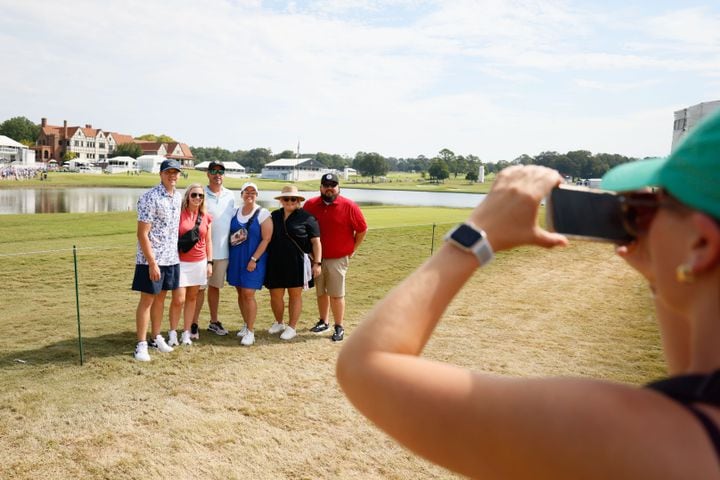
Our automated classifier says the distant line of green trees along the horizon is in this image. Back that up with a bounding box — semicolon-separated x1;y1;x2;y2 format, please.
0;117;636;182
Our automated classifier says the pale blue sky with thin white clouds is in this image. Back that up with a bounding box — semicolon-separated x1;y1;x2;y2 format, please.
0;0;720;161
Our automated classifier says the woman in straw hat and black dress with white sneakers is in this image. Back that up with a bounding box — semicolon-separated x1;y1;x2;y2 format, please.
265;185;322;340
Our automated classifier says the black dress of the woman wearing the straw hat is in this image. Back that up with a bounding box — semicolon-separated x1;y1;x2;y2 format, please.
265;208;320;288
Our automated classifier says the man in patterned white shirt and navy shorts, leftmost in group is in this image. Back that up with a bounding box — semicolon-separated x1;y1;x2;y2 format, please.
132;160;182;362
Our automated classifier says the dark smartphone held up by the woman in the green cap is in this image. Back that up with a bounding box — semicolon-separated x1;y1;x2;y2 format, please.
545;185;633;244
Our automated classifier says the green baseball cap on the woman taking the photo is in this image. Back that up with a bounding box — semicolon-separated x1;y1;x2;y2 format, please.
600;110;720;219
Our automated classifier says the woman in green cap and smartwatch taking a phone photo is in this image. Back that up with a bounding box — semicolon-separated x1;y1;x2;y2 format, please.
337;113;720;480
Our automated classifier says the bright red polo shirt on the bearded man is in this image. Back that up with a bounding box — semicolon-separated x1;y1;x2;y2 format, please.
303;195;367;258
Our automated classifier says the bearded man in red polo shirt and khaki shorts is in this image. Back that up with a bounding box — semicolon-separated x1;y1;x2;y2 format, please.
303;173;367;342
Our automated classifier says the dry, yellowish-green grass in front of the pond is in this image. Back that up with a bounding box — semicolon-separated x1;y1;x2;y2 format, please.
0;207;664;479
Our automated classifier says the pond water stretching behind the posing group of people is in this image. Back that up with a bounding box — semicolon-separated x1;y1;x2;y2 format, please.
0;188;485;214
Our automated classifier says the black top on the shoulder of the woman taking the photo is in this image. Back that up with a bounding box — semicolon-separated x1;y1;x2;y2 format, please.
646;370;720;459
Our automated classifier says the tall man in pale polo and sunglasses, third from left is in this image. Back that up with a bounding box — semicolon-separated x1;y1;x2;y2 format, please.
190;161;235;339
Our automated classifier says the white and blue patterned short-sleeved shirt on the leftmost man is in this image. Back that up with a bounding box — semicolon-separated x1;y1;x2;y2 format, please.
135;183;182;266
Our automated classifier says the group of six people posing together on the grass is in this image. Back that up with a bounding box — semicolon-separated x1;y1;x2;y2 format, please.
132;160;367;361
